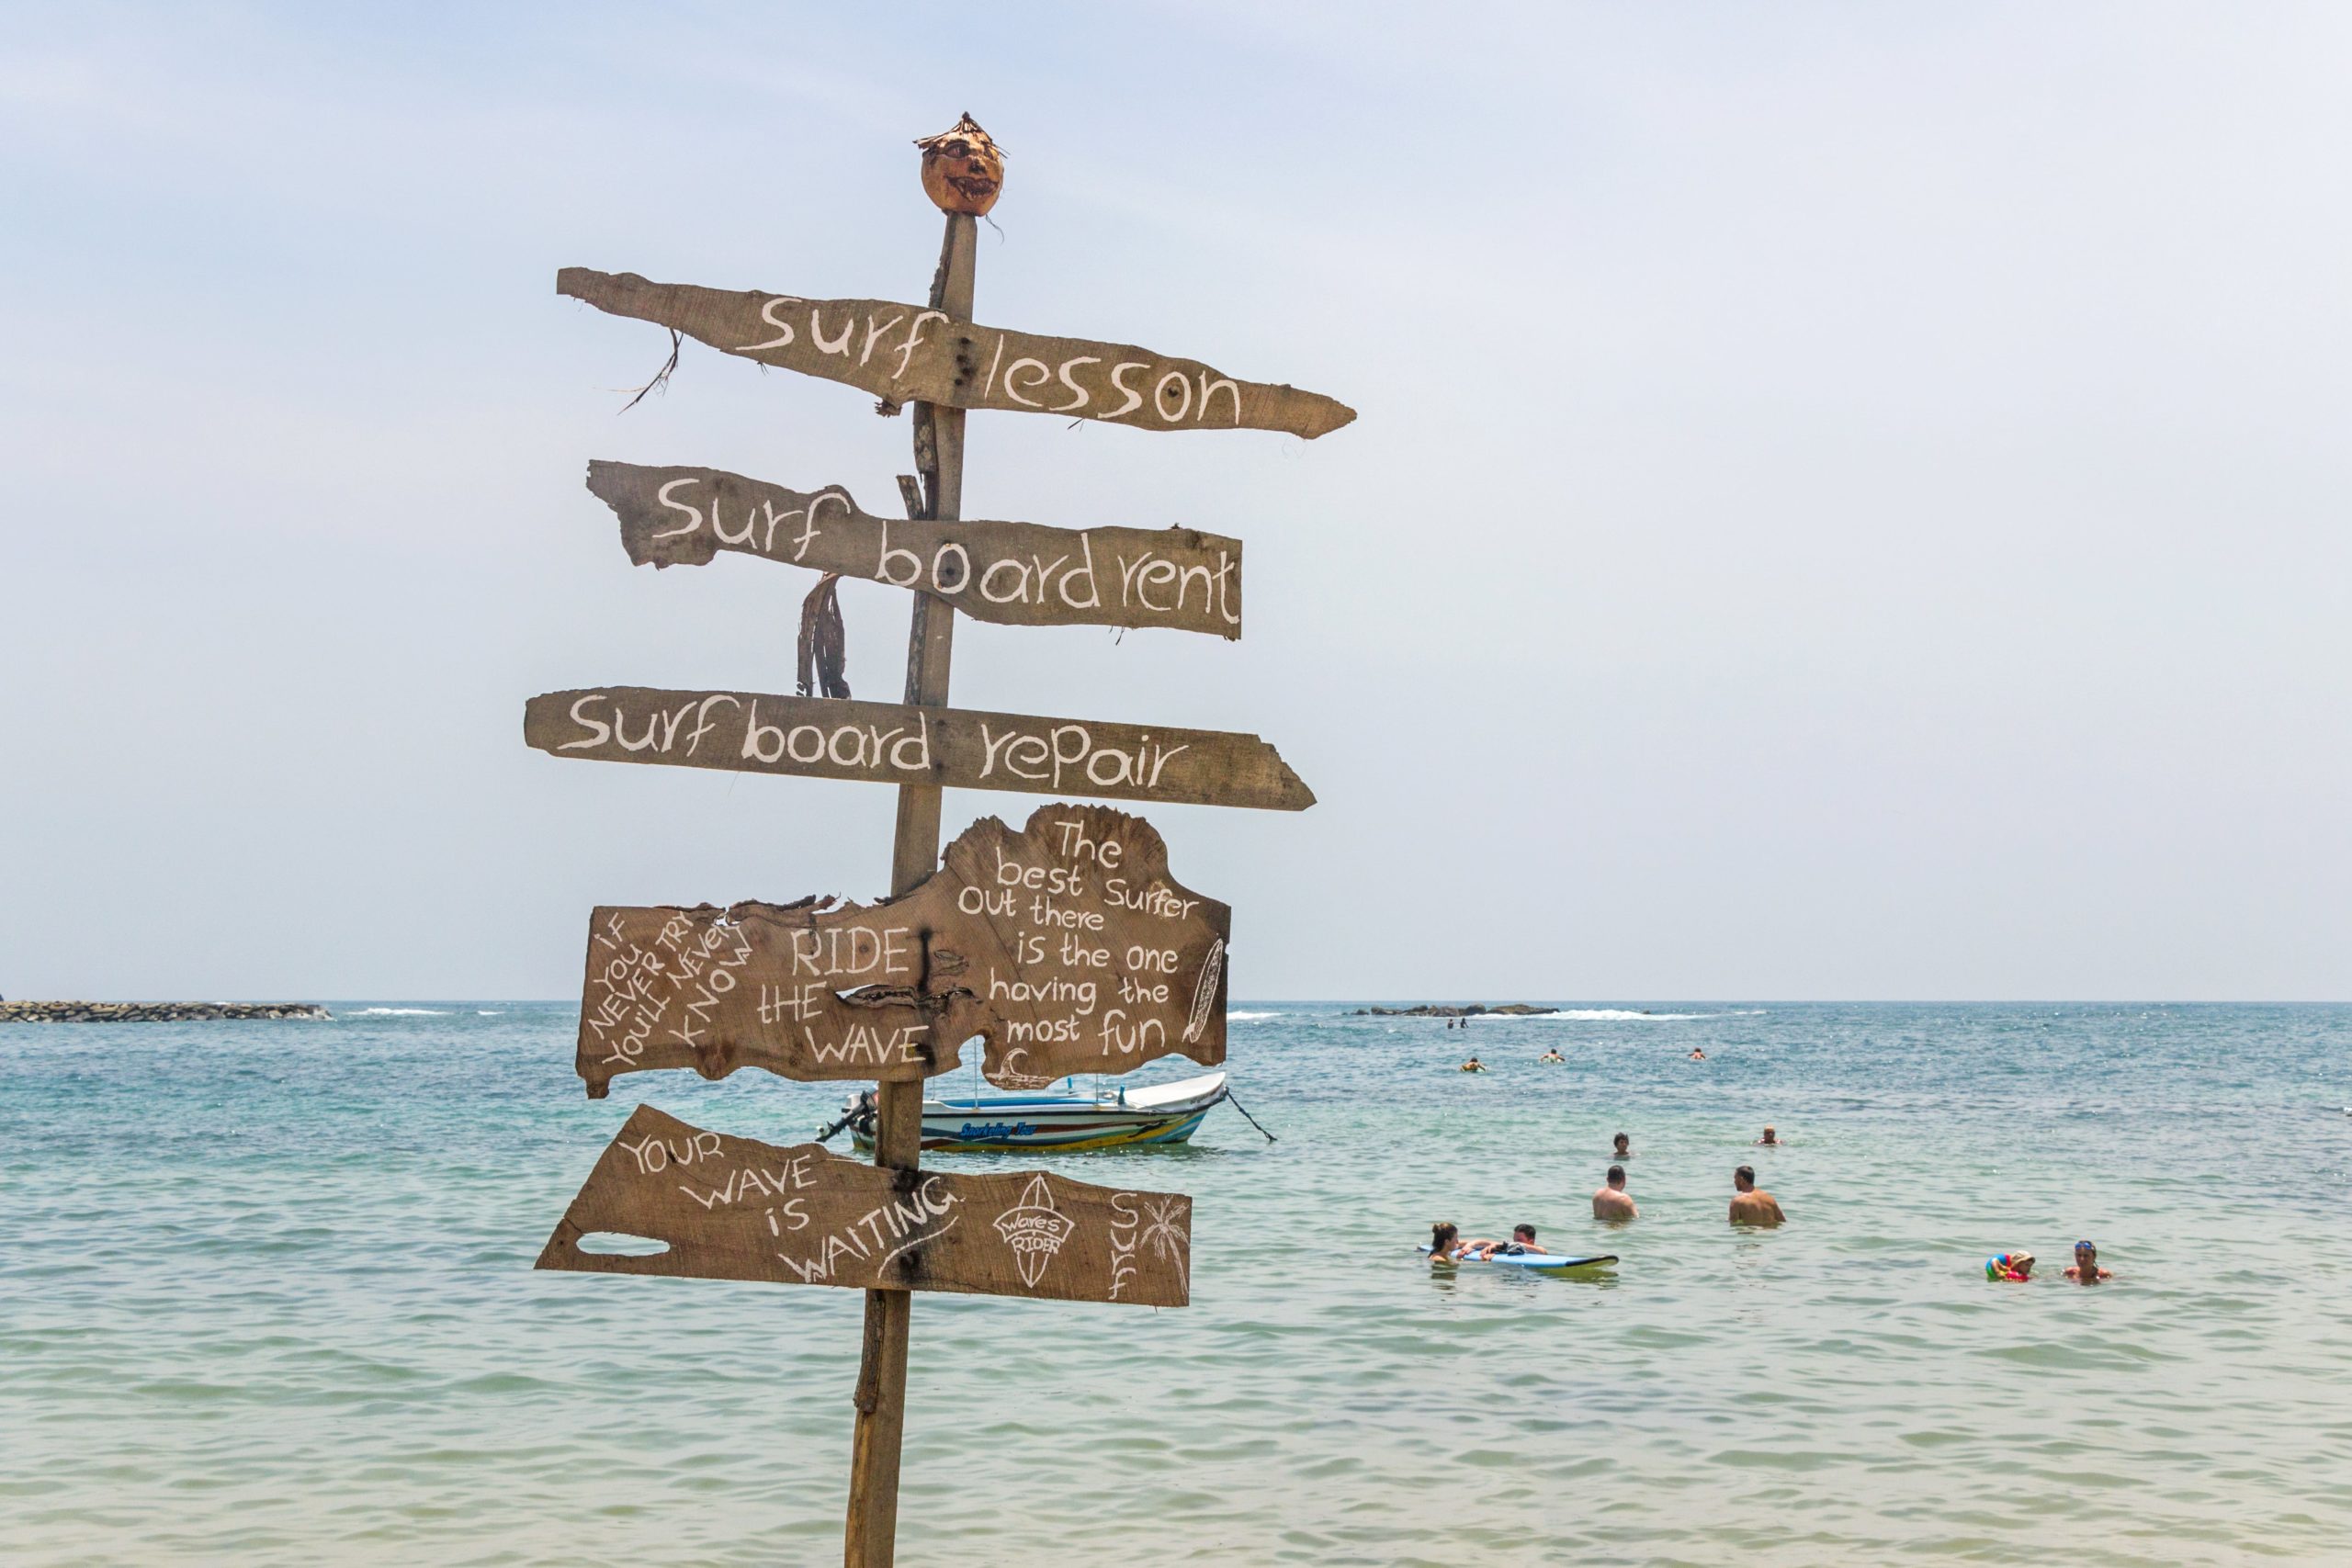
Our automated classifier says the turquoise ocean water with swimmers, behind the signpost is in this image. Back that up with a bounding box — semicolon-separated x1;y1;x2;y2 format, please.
0;1001;2352;1568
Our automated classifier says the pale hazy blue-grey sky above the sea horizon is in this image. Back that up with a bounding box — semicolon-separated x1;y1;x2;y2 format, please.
0;0;2352;1001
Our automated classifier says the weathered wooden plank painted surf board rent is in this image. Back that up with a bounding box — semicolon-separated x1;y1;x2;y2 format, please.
588;463;1242;637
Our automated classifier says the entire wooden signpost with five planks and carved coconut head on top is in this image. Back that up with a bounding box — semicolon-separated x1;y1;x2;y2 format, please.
525;115;1355;1568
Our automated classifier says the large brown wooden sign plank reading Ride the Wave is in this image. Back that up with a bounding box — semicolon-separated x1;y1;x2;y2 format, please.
576;807;1232;1098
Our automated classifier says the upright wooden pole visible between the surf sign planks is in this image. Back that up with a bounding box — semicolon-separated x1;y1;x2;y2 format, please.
842;211;978;1568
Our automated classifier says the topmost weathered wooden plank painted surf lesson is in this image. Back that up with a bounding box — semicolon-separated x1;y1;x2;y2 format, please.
555;265;1355;440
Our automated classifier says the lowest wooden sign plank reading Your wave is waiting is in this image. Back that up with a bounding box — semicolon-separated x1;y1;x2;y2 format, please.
538;1105;1193;1307
